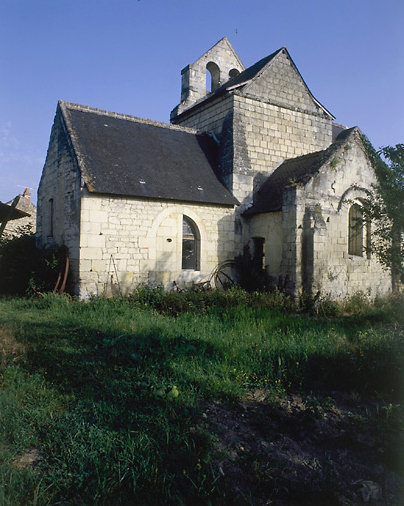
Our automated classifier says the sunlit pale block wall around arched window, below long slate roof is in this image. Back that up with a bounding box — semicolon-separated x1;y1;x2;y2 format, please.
79;194;234;297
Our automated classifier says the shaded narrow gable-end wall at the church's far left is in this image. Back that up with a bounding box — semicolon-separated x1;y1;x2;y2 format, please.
36;112;81;290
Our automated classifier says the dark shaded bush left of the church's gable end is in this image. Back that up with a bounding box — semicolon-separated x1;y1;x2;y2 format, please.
0;230;63;296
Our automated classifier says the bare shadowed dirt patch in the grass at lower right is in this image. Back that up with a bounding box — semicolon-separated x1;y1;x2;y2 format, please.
201;390;404;506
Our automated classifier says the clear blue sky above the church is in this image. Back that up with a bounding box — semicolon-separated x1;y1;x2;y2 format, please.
0;0;404;206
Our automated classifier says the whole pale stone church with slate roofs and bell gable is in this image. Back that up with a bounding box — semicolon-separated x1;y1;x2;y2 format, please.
37;38;390;298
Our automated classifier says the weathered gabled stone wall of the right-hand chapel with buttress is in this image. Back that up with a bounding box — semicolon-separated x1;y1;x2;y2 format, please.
282;131;391;298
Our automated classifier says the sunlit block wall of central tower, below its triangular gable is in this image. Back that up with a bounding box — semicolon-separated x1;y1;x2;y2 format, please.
233;95;332;206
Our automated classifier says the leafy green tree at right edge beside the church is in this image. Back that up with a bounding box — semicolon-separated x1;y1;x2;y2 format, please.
363;138;404;291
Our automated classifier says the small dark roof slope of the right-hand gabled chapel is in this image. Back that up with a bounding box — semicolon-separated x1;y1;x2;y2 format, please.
243;127;356;216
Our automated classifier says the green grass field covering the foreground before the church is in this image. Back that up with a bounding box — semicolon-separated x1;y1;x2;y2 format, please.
0;287;404;506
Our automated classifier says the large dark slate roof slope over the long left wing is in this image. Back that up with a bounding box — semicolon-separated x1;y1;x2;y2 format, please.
60;102;238;205
